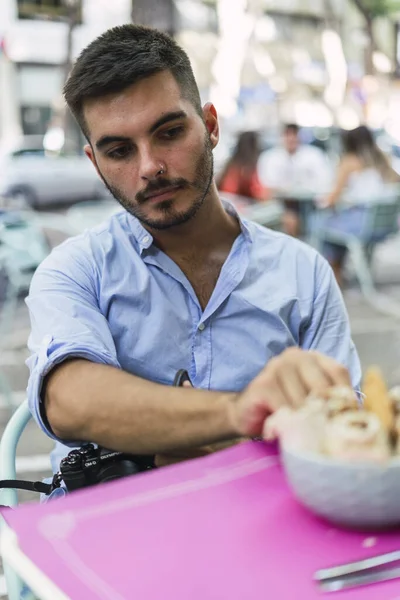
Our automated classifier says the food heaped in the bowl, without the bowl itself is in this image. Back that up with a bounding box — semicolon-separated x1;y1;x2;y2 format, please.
264;367;400;463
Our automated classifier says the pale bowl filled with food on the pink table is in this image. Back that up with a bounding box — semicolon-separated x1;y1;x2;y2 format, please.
264;368;400;531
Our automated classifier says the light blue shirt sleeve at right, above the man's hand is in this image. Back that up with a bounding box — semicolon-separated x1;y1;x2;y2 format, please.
300;255;361;388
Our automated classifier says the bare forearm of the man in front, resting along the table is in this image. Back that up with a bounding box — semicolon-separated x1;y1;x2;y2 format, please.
45;359;238;454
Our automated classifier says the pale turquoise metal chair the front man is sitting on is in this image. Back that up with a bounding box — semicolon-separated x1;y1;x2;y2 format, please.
0;400;33;600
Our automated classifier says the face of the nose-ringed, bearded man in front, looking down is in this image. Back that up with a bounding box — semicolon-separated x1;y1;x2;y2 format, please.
84;71;218;229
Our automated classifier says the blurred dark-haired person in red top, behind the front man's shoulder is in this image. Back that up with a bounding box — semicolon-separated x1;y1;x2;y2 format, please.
217;131;271;201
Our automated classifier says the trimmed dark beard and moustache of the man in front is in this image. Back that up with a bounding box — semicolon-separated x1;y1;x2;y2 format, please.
98;132;214;230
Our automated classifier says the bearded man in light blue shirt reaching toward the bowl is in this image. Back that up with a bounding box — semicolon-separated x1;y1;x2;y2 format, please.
27;25;360;476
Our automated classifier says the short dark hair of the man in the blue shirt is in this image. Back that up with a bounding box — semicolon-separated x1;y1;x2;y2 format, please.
64;24;202;138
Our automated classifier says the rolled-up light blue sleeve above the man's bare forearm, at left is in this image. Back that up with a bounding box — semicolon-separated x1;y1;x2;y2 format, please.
26;240;120;444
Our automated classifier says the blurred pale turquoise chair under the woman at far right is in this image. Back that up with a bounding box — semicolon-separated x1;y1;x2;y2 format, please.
309;194;400;318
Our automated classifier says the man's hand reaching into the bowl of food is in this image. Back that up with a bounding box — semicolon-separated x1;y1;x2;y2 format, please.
230;348;351;437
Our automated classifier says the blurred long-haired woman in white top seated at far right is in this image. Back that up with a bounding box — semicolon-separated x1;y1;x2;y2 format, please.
313;125;400;286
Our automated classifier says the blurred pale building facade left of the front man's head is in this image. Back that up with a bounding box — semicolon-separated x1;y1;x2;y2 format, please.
0;0;132;138
